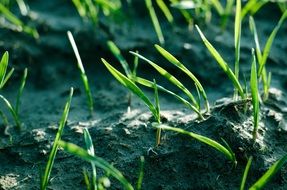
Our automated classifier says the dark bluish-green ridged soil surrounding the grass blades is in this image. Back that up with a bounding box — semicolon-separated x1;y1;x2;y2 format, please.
0;0;287;190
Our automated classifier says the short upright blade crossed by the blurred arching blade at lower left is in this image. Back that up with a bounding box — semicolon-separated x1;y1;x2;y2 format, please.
84;128;97;190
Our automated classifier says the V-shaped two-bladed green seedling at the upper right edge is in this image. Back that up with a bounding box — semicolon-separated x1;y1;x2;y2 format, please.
249;11;287;100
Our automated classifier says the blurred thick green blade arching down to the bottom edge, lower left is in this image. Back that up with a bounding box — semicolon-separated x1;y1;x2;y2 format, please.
57;140;134;190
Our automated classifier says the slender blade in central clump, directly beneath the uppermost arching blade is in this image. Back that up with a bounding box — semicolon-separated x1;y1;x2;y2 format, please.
130;51;199;108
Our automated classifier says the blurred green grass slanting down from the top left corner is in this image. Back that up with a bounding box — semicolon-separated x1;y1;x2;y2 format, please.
0;3;39;39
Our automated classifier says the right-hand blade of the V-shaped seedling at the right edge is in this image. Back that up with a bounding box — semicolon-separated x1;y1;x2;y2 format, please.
258;10;287;76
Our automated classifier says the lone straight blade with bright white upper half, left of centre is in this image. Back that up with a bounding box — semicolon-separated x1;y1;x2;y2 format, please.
67;31;94;115
